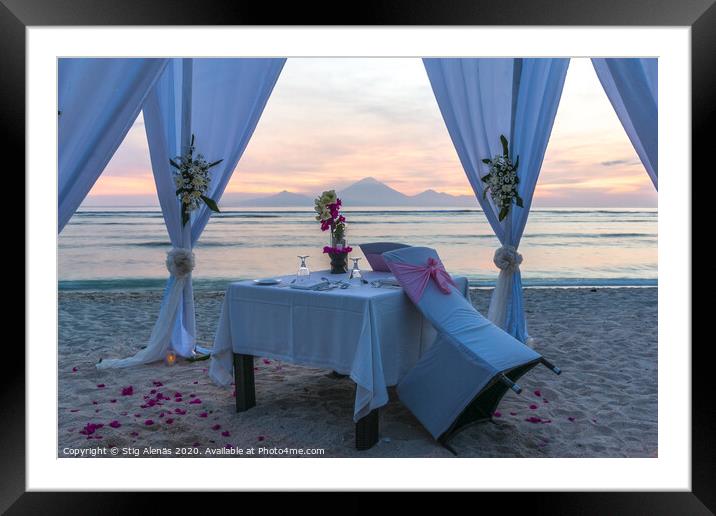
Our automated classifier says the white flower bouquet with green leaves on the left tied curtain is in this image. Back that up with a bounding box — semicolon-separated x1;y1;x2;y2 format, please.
169;134;224;225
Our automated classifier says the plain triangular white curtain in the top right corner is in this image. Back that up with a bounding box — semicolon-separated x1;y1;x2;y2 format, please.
592;58;659;189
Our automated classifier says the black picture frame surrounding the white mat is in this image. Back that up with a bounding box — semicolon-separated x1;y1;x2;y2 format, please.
0;0;716;514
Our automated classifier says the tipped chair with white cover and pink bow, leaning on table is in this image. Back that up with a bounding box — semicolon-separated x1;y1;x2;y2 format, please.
383;247;560;453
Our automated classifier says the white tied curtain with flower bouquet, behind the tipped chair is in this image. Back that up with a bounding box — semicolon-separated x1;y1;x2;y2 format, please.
423;58;569;342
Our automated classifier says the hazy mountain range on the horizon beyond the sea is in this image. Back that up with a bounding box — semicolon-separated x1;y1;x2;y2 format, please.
235;177;478;208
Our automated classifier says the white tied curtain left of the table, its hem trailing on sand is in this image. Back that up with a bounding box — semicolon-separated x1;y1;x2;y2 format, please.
99;58;285;367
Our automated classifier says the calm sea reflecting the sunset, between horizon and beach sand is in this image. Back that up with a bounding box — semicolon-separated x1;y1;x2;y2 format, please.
59;208;657;289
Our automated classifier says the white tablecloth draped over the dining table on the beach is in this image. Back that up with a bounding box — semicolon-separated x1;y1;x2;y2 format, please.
209;271;468;421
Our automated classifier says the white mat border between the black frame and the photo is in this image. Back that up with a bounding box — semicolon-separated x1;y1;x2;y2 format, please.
26;27;691;490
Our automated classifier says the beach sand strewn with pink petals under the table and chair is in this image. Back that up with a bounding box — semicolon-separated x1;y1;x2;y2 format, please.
58;288;657;457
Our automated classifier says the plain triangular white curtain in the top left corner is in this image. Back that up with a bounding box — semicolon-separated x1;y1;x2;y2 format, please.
57;58;167;233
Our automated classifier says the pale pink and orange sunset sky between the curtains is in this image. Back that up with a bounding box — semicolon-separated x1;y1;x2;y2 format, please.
83;58;657;207
